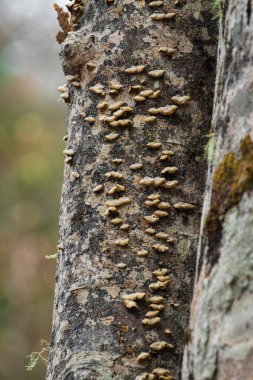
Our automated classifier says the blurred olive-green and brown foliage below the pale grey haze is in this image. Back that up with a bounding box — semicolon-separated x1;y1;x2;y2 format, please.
0;31;65;380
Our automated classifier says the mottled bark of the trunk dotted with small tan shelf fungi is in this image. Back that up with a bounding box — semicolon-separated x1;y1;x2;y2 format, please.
47;0;216;380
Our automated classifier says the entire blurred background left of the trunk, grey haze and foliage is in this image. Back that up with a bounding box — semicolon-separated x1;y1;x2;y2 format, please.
0;0;66;380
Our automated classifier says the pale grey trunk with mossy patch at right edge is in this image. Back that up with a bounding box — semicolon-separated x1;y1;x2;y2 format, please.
183;0;253;380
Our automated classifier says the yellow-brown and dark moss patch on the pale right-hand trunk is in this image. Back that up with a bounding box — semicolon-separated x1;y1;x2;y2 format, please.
204;136;253;265
